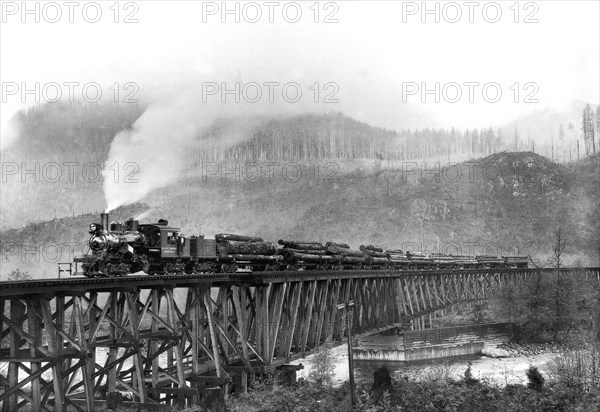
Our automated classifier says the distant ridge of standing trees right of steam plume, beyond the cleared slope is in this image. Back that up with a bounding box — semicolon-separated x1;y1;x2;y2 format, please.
191;113;506;162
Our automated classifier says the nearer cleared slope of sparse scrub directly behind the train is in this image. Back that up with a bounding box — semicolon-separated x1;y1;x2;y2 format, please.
0;152;600;277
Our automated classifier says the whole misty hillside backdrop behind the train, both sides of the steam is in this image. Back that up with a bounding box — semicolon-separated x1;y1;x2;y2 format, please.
0;101;600;276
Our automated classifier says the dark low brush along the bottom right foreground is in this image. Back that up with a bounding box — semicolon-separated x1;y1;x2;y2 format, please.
228;360;600;412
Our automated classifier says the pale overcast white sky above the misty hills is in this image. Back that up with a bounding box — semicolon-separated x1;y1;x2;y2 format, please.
0;1;600;150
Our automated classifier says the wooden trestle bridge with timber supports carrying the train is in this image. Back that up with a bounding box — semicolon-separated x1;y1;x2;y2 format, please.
0;268;600;412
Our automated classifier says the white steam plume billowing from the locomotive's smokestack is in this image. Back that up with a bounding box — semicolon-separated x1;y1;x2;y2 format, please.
102;79;306;212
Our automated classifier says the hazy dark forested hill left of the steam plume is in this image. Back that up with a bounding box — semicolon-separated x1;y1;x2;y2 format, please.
0;103;144;228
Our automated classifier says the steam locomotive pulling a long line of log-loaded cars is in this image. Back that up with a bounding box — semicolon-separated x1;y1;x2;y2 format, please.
75;213;528;277
